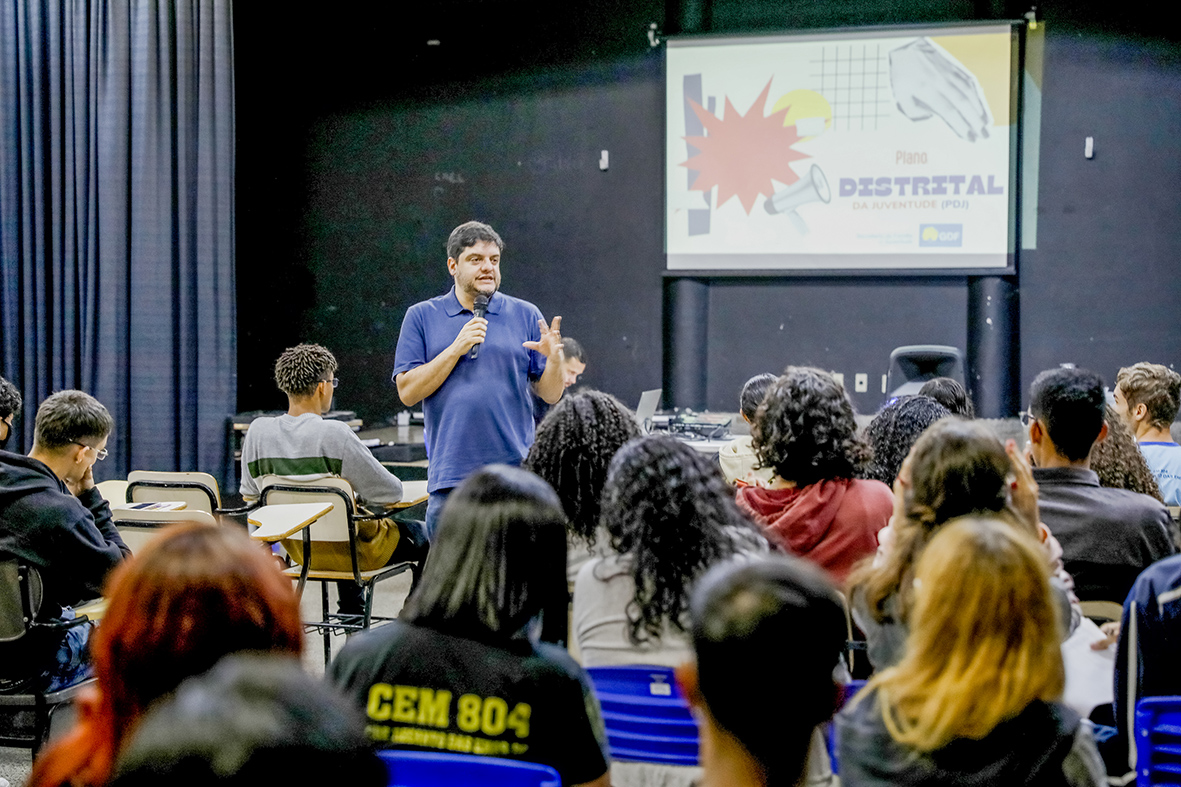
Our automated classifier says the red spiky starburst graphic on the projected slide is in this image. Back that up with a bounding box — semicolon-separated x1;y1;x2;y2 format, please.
680;80;808;215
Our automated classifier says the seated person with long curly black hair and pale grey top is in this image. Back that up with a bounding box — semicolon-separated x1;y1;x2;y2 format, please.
574;437;768;666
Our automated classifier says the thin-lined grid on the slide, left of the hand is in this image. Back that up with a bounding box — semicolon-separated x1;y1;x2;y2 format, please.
809;44;890;131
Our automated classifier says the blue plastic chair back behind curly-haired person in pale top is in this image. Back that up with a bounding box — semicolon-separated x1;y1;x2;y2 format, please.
587;665;700;766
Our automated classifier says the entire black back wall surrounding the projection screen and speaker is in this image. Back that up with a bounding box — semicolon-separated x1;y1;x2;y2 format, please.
235;0;1181;422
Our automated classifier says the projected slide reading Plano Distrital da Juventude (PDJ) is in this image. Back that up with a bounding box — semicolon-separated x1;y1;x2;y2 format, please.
665;24;1017;272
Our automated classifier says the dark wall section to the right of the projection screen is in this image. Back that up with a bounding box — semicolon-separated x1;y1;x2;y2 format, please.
1020;33;1181;394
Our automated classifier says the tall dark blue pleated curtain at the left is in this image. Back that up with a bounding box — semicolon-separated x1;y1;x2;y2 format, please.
0;0;237;479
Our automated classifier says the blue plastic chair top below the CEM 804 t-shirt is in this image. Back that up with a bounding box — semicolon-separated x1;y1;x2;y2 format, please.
378;749;562;787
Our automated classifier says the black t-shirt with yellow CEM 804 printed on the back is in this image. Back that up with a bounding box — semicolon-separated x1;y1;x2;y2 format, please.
329;622;608;785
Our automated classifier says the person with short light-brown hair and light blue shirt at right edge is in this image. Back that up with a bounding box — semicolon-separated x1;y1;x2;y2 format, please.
1115;363;1181;506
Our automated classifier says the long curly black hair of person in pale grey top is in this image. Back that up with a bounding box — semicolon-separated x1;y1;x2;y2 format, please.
602;437;765;644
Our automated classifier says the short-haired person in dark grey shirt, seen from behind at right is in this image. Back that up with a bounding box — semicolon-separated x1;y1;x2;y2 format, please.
1029;369;1175;600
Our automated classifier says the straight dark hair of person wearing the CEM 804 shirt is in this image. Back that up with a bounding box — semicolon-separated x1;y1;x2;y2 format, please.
399;464;568;642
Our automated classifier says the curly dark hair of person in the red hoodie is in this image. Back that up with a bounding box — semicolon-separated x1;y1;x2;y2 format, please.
750;366;869;487
